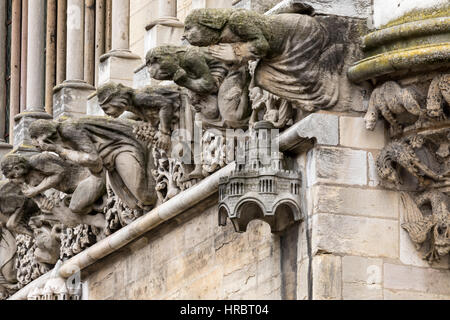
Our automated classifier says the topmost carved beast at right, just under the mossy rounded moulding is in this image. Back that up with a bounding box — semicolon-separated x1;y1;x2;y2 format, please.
364;81;425;135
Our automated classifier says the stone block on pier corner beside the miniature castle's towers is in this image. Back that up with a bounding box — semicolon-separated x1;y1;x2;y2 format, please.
307;147;367;187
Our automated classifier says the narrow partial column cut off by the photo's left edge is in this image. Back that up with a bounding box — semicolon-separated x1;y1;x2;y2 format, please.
0;2;11;158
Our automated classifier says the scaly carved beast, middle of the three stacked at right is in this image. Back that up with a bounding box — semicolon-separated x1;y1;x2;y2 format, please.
376;140;443;186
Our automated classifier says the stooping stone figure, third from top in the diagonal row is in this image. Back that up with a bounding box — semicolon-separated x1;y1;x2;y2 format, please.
97;83;182;150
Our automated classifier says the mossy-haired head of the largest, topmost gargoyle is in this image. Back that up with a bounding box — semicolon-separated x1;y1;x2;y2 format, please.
183;9;232;47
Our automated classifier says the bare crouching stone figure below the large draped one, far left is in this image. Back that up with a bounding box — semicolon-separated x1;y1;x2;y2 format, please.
1;152;106;228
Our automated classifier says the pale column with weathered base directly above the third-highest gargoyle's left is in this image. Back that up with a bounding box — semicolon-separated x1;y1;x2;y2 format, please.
53;0;95;118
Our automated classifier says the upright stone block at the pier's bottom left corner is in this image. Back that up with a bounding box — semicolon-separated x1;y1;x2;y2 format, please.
312;254;342;300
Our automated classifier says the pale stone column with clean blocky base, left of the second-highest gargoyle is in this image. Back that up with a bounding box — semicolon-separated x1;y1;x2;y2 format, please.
98;0;142;87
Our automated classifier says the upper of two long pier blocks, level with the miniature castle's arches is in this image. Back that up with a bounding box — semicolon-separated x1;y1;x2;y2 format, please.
313;185;400;219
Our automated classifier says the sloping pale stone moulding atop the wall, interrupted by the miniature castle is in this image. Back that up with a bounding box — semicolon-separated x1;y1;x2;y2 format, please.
9;114;337;300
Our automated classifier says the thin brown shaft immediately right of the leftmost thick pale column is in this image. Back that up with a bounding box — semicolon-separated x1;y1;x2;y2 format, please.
45;0;57;114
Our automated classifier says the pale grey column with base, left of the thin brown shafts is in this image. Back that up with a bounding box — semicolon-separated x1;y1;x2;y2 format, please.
14;0;51;147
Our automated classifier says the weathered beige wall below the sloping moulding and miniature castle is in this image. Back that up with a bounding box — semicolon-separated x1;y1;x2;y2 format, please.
82;196;294;299
